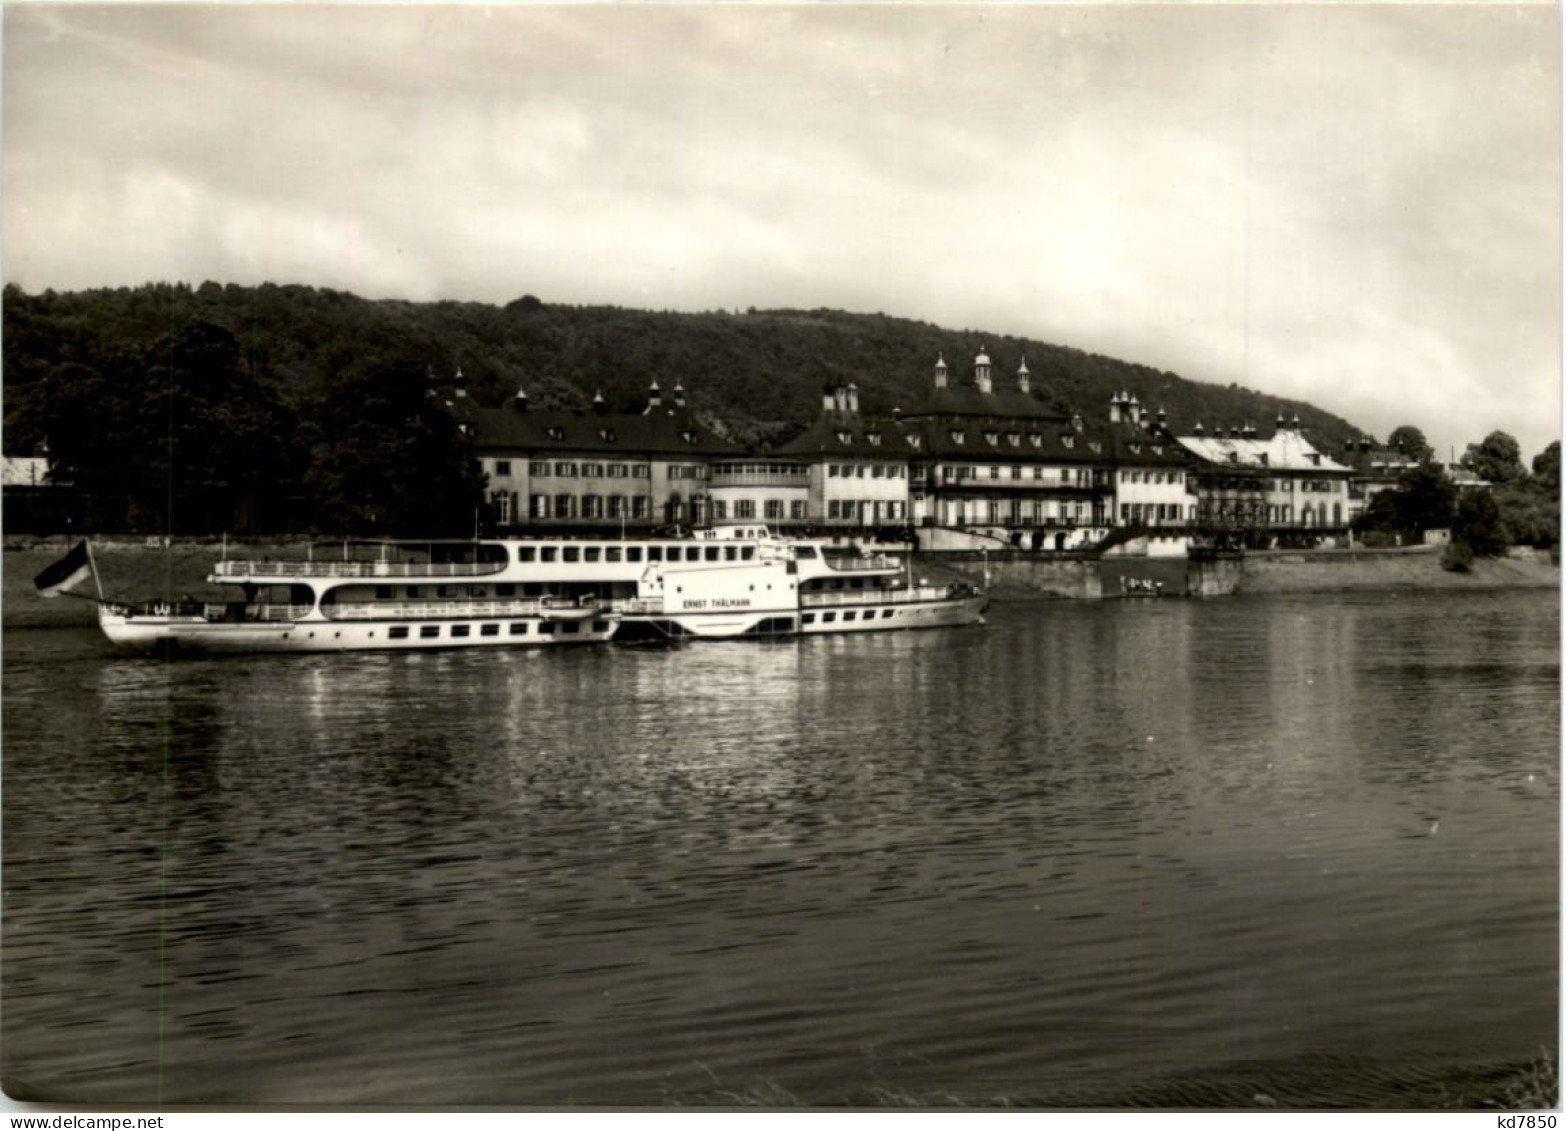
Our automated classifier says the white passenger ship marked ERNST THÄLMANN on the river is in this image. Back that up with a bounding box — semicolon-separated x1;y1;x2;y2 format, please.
99;526;985;652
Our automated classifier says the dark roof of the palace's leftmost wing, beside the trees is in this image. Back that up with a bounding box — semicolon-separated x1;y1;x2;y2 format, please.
451;401;742;457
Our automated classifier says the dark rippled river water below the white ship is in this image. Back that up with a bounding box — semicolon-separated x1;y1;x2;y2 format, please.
0;592;1560;1108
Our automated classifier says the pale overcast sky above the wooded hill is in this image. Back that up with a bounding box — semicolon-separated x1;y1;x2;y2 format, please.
3;5;1561;459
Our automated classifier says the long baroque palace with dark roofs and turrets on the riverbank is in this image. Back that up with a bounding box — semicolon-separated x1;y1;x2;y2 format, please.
446;352;1362;550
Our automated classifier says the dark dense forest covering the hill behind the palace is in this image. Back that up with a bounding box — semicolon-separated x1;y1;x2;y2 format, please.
3;282;1358;529
